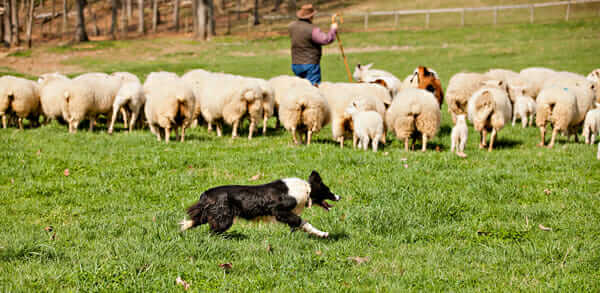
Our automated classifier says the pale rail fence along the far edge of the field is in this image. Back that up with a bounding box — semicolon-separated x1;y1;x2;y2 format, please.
262;0;600;30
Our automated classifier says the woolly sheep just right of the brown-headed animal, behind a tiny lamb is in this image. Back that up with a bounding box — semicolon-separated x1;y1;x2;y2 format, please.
446;72;491;122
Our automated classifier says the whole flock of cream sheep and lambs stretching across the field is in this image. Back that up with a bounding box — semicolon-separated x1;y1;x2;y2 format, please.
0;65;600;159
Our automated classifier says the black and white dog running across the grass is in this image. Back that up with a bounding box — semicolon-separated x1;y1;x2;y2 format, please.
179;171;340;238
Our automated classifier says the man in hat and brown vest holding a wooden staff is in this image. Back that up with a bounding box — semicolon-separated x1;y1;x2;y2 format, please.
288;4;337;85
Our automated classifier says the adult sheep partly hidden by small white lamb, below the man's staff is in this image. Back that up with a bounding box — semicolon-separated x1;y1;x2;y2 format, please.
319;82;391;148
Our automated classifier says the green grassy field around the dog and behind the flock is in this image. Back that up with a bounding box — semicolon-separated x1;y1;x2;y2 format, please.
0;20;600;292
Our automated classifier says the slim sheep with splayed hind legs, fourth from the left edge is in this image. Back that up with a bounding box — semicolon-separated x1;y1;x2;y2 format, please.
108;81;146;133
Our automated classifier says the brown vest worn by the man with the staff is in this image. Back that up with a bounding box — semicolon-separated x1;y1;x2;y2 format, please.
288;20;323;64
